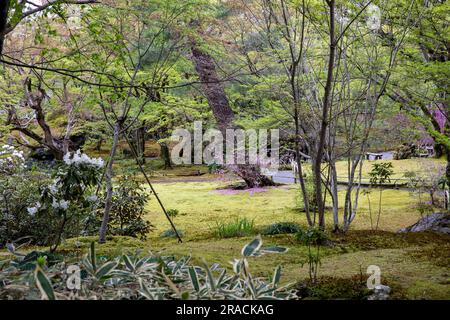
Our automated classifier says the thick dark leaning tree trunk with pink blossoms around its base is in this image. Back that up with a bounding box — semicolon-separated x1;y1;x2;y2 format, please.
191;42;273;188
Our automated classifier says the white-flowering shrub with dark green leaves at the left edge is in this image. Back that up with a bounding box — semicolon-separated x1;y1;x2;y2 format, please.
0;146;104;250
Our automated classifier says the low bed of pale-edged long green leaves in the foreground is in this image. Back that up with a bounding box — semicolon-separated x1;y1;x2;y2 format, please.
0;236;295;300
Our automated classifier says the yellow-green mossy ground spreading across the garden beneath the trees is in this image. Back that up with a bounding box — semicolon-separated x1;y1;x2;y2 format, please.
4;160;450;299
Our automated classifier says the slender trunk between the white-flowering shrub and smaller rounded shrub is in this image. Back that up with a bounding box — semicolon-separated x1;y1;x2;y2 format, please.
98;120;122;243
